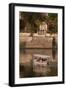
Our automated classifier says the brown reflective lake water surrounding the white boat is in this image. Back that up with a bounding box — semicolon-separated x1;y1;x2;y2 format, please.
19;49;58;78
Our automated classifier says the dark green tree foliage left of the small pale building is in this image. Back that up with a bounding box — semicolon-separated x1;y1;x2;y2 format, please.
20;12;46;36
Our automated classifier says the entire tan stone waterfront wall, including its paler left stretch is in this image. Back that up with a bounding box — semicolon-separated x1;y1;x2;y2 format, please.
20;32;57;48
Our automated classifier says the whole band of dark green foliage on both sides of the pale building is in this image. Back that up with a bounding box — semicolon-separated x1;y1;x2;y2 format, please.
20;12;58;36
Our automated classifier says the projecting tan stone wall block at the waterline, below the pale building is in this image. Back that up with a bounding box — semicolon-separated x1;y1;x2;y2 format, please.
26;37;52;48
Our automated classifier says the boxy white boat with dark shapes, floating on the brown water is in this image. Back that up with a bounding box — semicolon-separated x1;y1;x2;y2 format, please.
33;54;50;66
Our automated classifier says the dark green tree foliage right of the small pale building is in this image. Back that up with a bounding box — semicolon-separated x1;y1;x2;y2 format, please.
48;13;58;34
